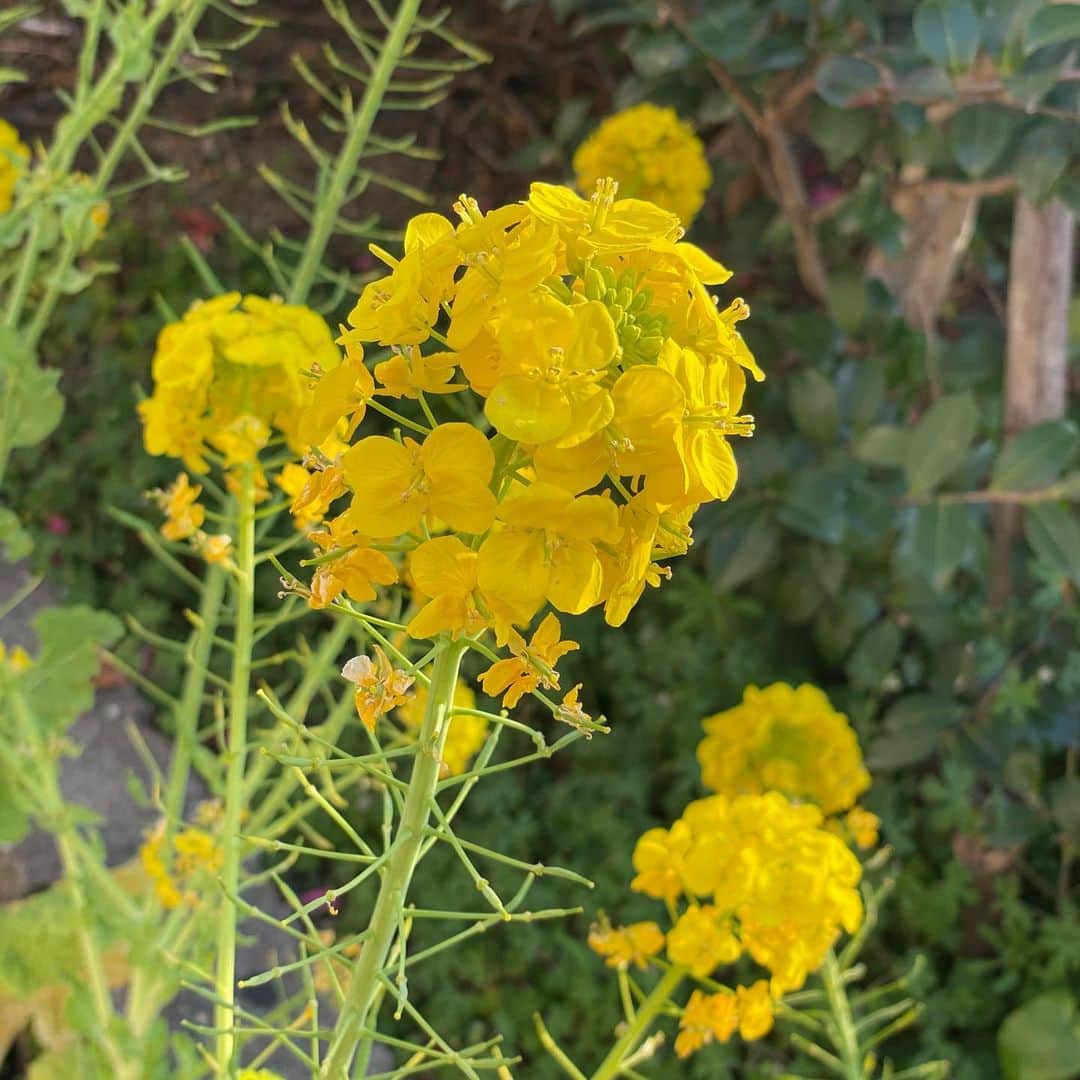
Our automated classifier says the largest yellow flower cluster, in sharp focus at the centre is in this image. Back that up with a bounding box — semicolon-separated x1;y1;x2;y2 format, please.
288;181;761;678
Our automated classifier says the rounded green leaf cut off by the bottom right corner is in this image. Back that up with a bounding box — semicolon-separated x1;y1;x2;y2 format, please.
998;986;1080;1080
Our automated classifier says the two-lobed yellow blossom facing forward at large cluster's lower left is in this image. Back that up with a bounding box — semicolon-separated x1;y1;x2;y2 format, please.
342;423;496;537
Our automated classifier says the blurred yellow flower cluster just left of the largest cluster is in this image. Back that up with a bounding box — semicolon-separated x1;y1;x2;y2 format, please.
138;293;340;473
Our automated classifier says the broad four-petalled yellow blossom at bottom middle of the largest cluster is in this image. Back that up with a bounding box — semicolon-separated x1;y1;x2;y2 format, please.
478;483;621;622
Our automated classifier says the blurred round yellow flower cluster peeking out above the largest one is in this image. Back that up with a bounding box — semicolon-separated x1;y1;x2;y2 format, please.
573;102;713;228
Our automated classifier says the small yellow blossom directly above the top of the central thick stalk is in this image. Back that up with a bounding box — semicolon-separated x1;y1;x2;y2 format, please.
408;537;487;637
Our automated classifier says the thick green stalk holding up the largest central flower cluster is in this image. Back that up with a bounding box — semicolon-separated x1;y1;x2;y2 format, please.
322;640;467;1080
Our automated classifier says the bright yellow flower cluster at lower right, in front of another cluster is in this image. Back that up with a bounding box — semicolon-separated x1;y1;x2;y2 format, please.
631;792;863;994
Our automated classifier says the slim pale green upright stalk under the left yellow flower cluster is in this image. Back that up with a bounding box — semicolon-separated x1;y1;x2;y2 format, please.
214;461;255;1076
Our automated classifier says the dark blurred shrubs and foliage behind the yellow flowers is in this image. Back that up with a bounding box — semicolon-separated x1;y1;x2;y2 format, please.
0;0;1080;1080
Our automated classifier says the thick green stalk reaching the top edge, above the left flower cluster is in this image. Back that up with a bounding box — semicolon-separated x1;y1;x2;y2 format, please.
288;0;421;303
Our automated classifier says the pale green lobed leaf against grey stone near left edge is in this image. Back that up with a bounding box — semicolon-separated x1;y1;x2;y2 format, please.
23;605;123;732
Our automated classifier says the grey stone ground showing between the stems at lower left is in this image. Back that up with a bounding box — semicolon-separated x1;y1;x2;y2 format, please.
0;564;393;1080
